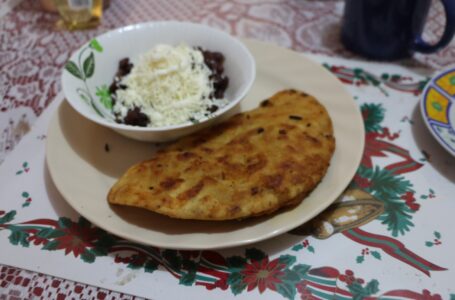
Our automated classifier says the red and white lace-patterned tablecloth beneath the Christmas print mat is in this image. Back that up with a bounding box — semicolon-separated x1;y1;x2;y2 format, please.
0;0;455;299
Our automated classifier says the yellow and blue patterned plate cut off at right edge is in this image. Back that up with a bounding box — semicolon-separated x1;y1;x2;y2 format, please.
420;68;455;156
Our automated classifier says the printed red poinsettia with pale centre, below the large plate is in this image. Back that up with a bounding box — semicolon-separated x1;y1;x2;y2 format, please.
241;258;286;294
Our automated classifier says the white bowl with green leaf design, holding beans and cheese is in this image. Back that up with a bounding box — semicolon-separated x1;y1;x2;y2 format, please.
62;21;256;142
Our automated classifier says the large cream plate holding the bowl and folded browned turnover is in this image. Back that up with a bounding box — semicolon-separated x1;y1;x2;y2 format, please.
47;41;365;249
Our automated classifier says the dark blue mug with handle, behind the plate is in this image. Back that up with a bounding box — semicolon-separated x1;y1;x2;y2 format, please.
341;0;455;60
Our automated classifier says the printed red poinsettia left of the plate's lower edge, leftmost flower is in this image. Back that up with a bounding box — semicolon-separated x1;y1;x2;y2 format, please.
55;223;98;257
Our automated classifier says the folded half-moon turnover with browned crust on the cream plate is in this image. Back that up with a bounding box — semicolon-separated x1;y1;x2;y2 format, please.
108;90;335;220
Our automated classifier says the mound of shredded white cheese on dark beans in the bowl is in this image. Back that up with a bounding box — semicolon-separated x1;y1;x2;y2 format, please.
113;44;226;127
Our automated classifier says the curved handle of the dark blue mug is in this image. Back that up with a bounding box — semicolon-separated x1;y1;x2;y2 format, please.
414;0;455;54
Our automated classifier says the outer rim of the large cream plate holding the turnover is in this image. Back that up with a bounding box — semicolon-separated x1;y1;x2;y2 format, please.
46;39;365;250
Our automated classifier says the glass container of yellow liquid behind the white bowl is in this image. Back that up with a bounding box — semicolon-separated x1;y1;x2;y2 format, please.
54;0;103;30
